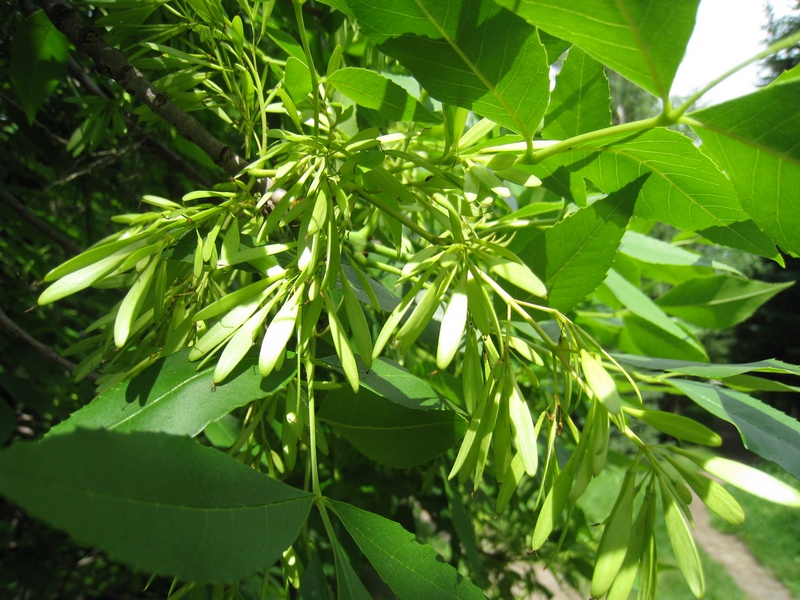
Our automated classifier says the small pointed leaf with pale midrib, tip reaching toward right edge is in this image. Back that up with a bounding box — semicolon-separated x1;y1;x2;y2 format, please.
656;275;794;329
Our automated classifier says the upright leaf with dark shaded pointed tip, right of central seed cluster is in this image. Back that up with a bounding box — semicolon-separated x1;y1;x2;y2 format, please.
519;173;650;312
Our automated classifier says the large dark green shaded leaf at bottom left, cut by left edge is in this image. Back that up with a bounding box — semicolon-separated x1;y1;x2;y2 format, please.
0;430;312;583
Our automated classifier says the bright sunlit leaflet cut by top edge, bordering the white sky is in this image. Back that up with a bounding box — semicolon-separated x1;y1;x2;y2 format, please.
496;0;699;98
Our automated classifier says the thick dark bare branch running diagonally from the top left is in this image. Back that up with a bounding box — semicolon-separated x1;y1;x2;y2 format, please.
39;0;247;175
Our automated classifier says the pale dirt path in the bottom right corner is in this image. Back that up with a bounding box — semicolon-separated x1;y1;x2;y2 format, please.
690;498;793;600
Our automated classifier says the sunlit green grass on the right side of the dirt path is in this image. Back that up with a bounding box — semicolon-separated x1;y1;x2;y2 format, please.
711;463;800;598
